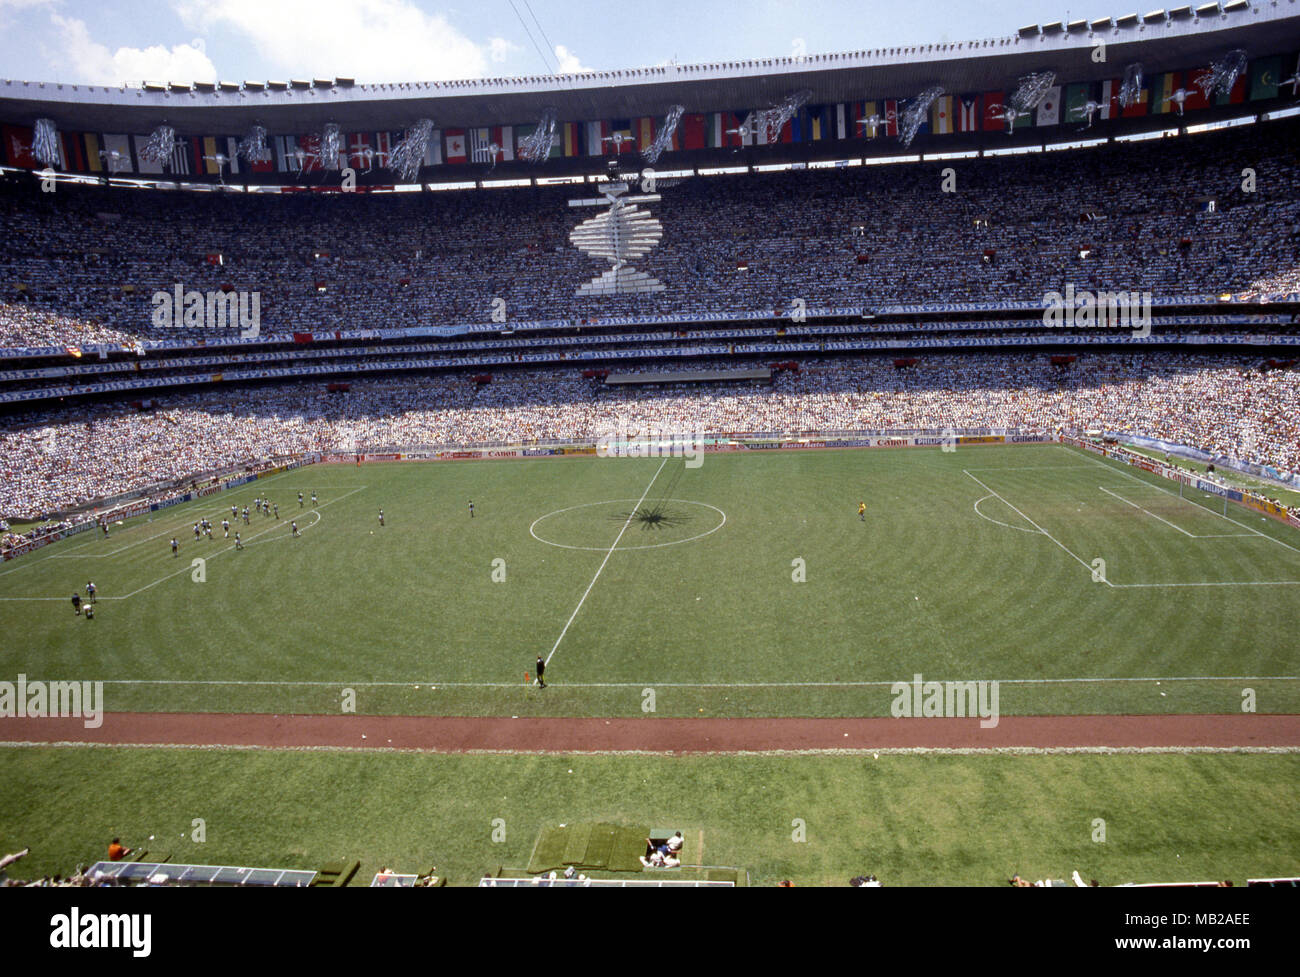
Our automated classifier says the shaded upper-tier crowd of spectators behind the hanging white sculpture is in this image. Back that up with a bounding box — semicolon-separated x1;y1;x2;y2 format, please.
0;120;1300;346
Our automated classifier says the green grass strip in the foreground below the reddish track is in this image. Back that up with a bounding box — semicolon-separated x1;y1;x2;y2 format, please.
0;747;1300;885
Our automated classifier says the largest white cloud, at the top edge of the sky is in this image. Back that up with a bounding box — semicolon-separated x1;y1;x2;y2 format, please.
177;0;488;83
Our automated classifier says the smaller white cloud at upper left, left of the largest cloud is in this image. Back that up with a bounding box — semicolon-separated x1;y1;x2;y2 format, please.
46;13;217;84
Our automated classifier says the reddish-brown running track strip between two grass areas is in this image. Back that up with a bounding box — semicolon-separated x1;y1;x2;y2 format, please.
0;712;1300;754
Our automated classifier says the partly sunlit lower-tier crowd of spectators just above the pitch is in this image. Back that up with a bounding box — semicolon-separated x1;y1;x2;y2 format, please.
0;352;1300;518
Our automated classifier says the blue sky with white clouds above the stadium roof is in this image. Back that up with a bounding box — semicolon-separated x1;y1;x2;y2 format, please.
0;0;1071;84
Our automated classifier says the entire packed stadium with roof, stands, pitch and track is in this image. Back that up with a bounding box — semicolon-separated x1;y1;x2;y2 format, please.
0;0;1300;887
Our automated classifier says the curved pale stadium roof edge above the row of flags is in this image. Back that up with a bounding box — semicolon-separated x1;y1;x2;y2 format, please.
0;0;1300;135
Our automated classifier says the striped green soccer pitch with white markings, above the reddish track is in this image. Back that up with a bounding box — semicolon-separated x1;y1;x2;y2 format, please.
0;446;1300;716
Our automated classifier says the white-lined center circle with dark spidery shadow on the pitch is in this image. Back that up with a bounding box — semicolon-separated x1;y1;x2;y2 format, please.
528;499;727;553
